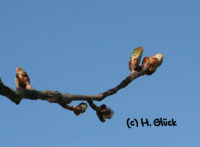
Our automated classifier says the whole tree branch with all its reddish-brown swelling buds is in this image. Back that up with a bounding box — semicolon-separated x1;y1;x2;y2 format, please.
0;47;163;122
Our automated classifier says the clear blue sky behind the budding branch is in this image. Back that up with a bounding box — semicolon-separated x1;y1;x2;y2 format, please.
0;0;200;147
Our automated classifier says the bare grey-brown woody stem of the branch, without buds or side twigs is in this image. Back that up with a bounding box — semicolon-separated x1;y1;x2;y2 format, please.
0;70;145;103
